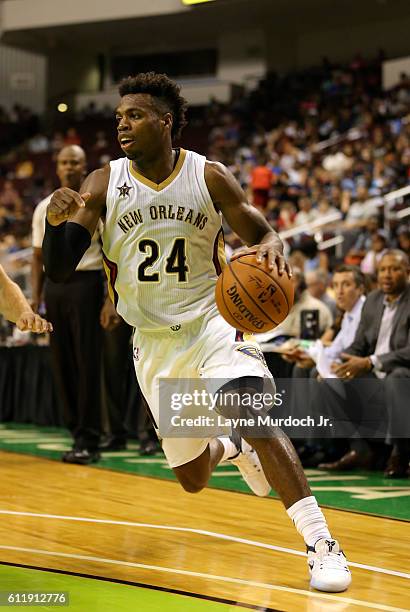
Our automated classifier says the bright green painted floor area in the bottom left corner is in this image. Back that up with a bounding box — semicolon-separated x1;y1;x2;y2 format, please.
0;565;256;612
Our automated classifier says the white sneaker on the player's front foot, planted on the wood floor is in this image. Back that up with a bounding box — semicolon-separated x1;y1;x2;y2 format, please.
306;538;352;593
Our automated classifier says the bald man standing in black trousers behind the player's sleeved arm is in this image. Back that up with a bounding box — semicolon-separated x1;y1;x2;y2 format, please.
32;145;104;465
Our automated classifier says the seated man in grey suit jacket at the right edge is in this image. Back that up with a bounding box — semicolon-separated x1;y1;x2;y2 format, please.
322;250;410;478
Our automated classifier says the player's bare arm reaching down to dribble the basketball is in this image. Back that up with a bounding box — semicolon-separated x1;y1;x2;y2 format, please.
205;162;292;276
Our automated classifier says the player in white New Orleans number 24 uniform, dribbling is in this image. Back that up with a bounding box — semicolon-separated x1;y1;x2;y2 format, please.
43;73;351;591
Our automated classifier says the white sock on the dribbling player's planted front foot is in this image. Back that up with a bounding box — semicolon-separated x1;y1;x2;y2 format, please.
286;495;331;546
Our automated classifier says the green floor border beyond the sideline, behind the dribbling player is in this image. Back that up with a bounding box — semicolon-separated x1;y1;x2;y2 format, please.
0;423;410;521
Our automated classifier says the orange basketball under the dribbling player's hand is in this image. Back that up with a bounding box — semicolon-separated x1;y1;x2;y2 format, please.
215;254;294;333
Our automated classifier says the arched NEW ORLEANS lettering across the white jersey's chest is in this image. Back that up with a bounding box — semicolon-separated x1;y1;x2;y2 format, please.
117;206;208;234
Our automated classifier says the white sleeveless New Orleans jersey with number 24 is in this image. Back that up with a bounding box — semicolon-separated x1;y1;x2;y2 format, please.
102;149;225;331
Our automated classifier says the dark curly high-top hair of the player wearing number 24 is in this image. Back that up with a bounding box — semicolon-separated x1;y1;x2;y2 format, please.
118;72;187;138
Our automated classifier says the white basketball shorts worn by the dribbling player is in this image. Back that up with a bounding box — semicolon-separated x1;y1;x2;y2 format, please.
133;306;273;467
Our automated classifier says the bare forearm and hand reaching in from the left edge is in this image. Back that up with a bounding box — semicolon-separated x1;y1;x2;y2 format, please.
0;266;53;334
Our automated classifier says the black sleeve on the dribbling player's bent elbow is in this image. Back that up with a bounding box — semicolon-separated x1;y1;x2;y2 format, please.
43;219;91;283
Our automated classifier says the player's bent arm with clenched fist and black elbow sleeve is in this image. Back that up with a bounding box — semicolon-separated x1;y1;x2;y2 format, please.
43;166;110;282
